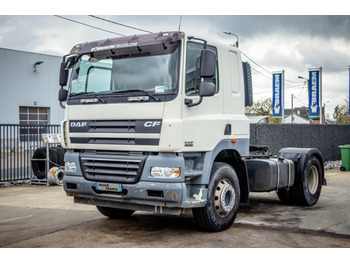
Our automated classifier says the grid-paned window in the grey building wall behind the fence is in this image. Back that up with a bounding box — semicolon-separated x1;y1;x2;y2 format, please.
19;106;50;142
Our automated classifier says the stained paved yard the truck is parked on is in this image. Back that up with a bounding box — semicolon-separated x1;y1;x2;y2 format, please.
0;169;350;248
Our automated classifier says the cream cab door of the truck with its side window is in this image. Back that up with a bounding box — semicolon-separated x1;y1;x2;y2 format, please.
182;41;225;151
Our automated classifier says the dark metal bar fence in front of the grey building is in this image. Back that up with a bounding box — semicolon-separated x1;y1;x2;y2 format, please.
0;124;60;183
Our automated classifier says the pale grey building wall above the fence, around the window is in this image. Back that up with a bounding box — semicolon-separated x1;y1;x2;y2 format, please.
0;48;64;124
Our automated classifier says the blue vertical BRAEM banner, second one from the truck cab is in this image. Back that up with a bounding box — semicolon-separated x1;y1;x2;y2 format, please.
309;69;320;116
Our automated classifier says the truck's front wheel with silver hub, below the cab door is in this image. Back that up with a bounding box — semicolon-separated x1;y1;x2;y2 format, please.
192;162;240;232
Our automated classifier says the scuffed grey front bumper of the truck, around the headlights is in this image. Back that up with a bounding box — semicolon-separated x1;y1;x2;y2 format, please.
63;151;207;211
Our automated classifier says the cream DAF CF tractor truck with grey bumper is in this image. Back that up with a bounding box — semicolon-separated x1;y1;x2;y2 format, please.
59;32;325;231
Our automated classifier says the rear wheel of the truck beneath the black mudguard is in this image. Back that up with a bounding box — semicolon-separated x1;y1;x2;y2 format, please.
277;157;323;206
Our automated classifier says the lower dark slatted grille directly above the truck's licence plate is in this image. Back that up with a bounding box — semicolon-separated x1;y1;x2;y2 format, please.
80;153;147;184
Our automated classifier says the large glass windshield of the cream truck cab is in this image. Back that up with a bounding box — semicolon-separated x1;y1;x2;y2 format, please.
69;48;179;97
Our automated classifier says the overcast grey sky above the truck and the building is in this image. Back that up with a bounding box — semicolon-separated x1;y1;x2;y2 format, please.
0;0;350;117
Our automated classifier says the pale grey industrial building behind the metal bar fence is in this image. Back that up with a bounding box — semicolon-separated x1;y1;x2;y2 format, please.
0;48;64;182
